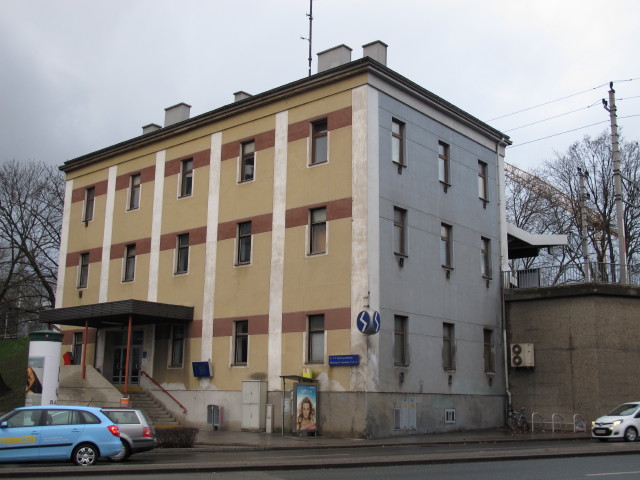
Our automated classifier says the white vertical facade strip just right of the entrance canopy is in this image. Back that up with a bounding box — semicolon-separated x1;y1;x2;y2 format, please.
200;132;222;368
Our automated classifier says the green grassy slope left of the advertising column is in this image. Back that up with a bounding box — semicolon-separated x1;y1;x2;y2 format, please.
0;337;29;413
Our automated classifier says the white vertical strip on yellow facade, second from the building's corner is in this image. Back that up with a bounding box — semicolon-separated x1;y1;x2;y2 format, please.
267;112;289;390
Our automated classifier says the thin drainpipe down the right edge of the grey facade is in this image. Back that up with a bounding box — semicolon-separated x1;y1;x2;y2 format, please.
496;137;511;418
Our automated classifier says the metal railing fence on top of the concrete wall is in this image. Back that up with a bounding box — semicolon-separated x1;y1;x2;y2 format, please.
502;262;640;288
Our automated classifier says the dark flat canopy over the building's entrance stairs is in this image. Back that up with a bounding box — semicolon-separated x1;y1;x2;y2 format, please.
40;300;193;328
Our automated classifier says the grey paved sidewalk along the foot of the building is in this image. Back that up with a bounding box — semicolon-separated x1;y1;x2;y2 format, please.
194;428;591;451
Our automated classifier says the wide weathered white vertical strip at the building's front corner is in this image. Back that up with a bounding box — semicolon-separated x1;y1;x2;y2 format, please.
350;85;379;391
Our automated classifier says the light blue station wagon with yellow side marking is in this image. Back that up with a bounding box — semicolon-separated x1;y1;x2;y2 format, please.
0;405;122;466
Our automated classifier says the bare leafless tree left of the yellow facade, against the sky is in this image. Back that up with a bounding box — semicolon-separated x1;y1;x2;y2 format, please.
0;160;64;334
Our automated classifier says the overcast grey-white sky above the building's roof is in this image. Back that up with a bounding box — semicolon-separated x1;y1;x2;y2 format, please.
0;0;640;172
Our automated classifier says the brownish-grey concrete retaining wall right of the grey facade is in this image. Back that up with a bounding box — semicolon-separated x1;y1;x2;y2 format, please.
505;284;640;425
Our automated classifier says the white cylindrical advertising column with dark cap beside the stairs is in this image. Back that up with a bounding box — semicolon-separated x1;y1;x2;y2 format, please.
24;330;63;406
